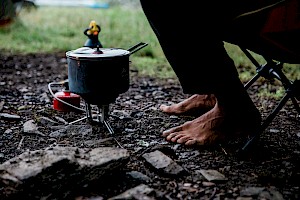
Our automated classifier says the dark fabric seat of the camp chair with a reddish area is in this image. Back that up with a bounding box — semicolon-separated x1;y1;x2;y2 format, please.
224;0;300;64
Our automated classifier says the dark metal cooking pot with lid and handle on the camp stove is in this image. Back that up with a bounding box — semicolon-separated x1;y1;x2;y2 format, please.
66;42;148;105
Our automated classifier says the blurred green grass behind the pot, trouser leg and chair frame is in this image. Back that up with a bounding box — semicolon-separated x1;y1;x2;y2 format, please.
0;6;300;81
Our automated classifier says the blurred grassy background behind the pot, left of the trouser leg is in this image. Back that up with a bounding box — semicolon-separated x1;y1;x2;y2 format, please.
0;0;174;77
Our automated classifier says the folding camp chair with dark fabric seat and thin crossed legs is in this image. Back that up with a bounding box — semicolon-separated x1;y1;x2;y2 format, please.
225;0;300;152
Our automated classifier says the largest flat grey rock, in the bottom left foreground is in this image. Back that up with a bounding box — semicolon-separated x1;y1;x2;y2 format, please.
0;147;129;199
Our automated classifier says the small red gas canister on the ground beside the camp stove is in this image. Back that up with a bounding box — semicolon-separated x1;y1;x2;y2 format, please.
53;91;80;112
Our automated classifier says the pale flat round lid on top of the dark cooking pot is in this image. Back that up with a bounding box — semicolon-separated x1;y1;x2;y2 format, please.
66;47;130;58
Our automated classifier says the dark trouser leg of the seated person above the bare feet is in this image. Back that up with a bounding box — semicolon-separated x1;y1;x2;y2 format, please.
141;0;245;94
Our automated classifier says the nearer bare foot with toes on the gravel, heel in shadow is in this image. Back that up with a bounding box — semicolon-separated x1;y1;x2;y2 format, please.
163;97;260;146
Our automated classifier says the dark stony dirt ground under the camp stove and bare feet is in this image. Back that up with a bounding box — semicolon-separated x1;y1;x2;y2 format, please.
0;53;300;200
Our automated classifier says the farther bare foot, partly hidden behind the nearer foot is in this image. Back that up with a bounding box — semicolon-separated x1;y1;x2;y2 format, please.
160;94;216;115
